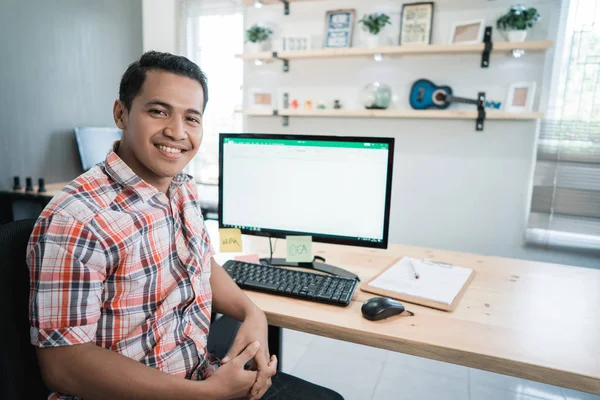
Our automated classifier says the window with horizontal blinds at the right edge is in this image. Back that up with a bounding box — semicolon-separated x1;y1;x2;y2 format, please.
526;0;600;252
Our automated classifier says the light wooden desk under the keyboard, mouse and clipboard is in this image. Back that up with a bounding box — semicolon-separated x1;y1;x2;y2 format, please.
237;237;600;394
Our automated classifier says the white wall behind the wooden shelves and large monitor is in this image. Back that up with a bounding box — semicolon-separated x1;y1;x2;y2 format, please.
244;0;600;267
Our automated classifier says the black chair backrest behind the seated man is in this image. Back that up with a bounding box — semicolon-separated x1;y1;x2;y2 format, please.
0;219;50;400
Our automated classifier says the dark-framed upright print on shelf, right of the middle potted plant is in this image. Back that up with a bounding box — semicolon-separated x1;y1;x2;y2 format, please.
399;1;434;46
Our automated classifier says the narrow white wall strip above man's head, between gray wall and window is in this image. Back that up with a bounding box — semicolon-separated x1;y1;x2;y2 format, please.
142;0;179;54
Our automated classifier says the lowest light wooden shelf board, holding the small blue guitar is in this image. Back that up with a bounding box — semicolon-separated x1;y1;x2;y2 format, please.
242;109;544;120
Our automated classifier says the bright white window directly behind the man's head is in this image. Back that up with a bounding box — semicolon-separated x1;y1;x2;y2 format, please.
181;0;244;185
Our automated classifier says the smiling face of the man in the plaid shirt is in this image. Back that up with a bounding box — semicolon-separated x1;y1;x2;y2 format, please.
114;70;204;185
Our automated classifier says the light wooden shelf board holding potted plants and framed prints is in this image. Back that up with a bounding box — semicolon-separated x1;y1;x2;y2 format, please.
236;40;553;60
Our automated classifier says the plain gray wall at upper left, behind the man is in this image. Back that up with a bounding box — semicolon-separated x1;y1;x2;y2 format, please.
0;0;142;189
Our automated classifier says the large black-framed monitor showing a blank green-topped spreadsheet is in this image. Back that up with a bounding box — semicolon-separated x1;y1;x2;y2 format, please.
219;134;394;248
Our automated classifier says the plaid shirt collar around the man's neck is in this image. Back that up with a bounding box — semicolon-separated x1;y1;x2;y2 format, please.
104;140;193;201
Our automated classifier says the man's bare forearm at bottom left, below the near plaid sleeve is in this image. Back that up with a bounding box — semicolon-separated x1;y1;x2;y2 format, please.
37;343;220;400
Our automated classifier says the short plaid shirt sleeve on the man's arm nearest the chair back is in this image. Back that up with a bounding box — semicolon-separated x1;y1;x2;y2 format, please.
27;214;107;347
